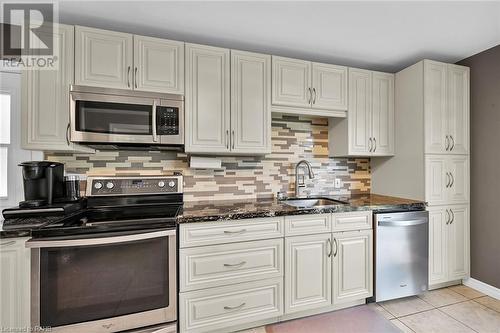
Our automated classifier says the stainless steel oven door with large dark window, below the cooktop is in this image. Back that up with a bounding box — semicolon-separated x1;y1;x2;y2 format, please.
27;230;177;332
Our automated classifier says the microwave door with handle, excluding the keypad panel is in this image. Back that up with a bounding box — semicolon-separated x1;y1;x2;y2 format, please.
70;92;160;144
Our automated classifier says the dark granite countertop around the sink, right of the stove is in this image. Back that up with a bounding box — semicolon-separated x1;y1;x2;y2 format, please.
177;194;426;223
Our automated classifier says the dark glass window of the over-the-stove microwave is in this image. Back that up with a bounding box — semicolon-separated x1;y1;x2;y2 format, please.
75;101;152;135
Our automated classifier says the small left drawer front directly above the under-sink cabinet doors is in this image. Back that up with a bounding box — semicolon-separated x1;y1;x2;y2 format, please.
285;214;332;236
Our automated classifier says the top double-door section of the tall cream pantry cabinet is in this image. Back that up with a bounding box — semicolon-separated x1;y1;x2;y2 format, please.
424;60;469;154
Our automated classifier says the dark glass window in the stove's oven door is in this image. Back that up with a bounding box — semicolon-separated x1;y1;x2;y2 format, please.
40;237;170;326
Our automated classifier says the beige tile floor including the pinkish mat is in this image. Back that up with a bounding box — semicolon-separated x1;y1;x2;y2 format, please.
242;285;500;333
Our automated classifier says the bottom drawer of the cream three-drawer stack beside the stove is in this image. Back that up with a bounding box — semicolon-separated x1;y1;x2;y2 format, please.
179;278;283;332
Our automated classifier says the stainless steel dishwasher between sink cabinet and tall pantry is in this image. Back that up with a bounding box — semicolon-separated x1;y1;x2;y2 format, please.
374;211;429;302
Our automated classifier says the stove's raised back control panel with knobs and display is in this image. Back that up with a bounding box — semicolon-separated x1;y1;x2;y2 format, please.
86;176;183;196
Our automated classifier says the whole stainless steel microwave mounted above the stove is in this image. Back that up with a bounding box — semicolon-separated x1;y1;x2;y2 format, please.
68;85;184;149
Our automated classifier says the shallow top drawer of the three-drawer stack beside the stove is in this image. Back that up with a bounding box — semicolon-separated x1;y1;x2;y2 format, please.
180;217;283;248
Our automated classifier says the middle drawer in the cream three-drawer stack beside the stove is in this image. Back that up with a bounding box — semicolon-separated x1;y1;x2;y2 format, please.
179;238;283;292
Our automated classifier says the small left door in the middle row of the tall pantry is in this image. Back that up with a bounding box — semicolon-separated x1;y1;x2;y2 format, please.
425;155;451;205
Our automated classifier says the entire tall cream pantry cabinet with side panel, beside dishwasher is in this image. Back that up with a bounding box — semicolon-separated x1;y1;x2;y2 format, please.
371;60;470;288
